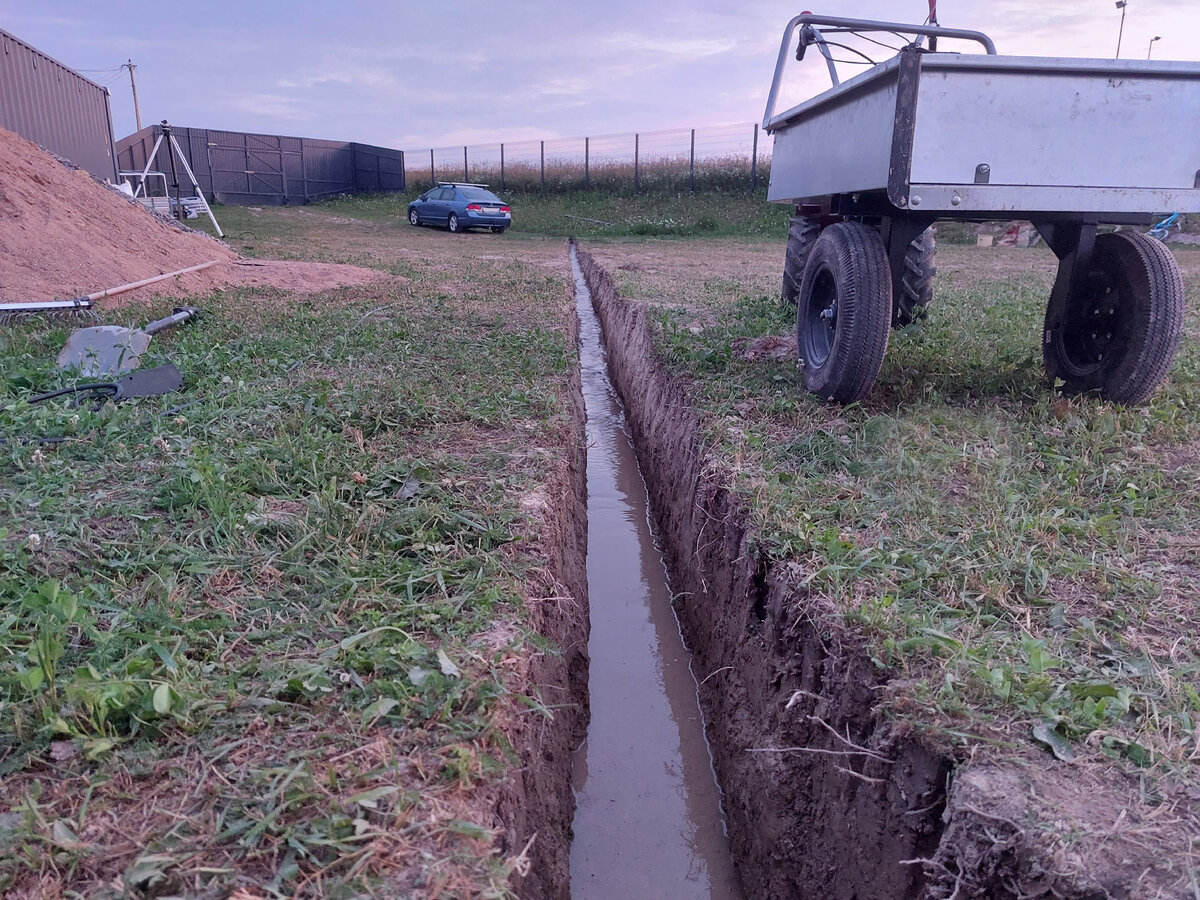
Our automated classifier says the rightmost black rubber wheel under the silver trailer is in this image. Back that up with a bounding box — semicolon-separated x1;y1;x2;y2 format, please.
1042;232;1184;404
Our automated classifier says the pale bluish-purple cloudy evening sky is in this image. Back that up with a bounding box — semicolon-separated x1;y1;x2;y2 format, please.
0;0;1200;150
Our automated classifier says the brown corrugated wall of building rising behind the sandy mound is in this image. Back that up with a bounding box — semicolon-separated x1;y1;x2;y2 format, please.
0;29;116;181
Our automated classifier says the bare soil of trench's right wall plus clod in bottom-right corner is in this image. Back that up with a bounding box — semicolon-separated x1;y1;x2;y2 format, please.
580;252;1196;900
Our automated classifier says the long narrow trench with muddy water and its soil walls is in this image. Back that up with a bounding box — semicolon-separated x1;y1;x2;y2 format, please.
530;246;1156;900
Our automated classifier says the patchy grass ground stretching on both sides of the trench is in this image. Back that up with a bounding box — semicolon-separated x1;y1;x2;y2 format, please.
0;192;1200;898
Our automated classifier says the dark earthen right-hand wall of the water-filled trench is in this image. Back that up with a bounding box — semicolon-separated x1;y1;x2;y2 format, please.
580;252;949;900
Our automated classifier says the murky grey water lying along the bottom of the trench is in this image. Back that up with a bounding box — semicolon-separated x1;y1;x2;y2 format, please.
571;247;743;900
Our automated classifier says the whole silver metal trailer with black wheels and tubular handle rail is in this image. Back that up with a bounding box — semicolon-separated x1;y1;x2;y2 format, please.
763;13;1200;403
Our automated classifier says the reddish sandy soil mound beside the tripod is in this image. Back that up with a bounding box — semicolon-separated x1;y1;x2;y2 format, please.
0;128;386;302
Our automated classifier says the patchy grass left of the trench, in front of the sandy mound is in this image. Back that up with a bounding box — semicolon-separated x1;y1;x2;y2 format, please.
0;230;572;898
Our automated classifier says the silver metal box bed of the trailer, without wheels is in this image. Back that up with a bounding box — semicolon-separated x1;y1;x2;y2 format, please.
764;53;1200;222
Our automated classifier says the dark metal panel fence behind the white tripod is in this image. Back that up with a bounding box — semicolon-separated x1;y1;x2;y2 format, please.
116;125;406;204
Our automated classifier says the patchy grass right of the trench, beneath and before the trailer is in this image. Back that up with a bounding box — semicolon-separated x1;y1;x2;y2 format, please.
598;246;1200;778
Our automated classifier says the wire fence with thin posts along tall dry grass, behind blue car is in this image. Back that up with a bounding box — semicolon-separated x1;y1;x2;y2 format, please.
404;125;770;193
